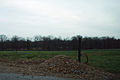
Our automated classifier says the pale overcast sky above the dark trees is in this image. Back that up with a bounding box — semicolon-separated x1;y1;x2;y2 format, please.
0;0;120;38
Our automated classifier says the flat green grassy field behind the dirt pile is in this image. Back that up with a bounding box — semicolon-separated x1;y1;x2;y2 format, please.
0;49;120;73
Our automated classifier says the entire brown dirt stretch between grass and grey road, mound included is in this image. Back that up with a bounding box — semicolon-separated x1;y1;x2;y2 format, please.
0;55;118;80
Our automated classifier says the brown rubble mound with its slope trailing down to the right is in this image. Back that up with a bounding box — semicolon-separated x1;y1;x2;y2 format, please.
39;55;112;80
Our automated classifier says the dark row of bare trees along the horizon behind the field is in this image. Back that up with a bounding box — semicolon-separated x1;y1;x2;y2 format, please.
0;35;120;51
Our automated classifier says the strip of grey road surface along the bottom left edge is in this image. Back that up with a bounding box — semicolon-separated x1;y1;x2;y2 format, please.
0;73;79;80
